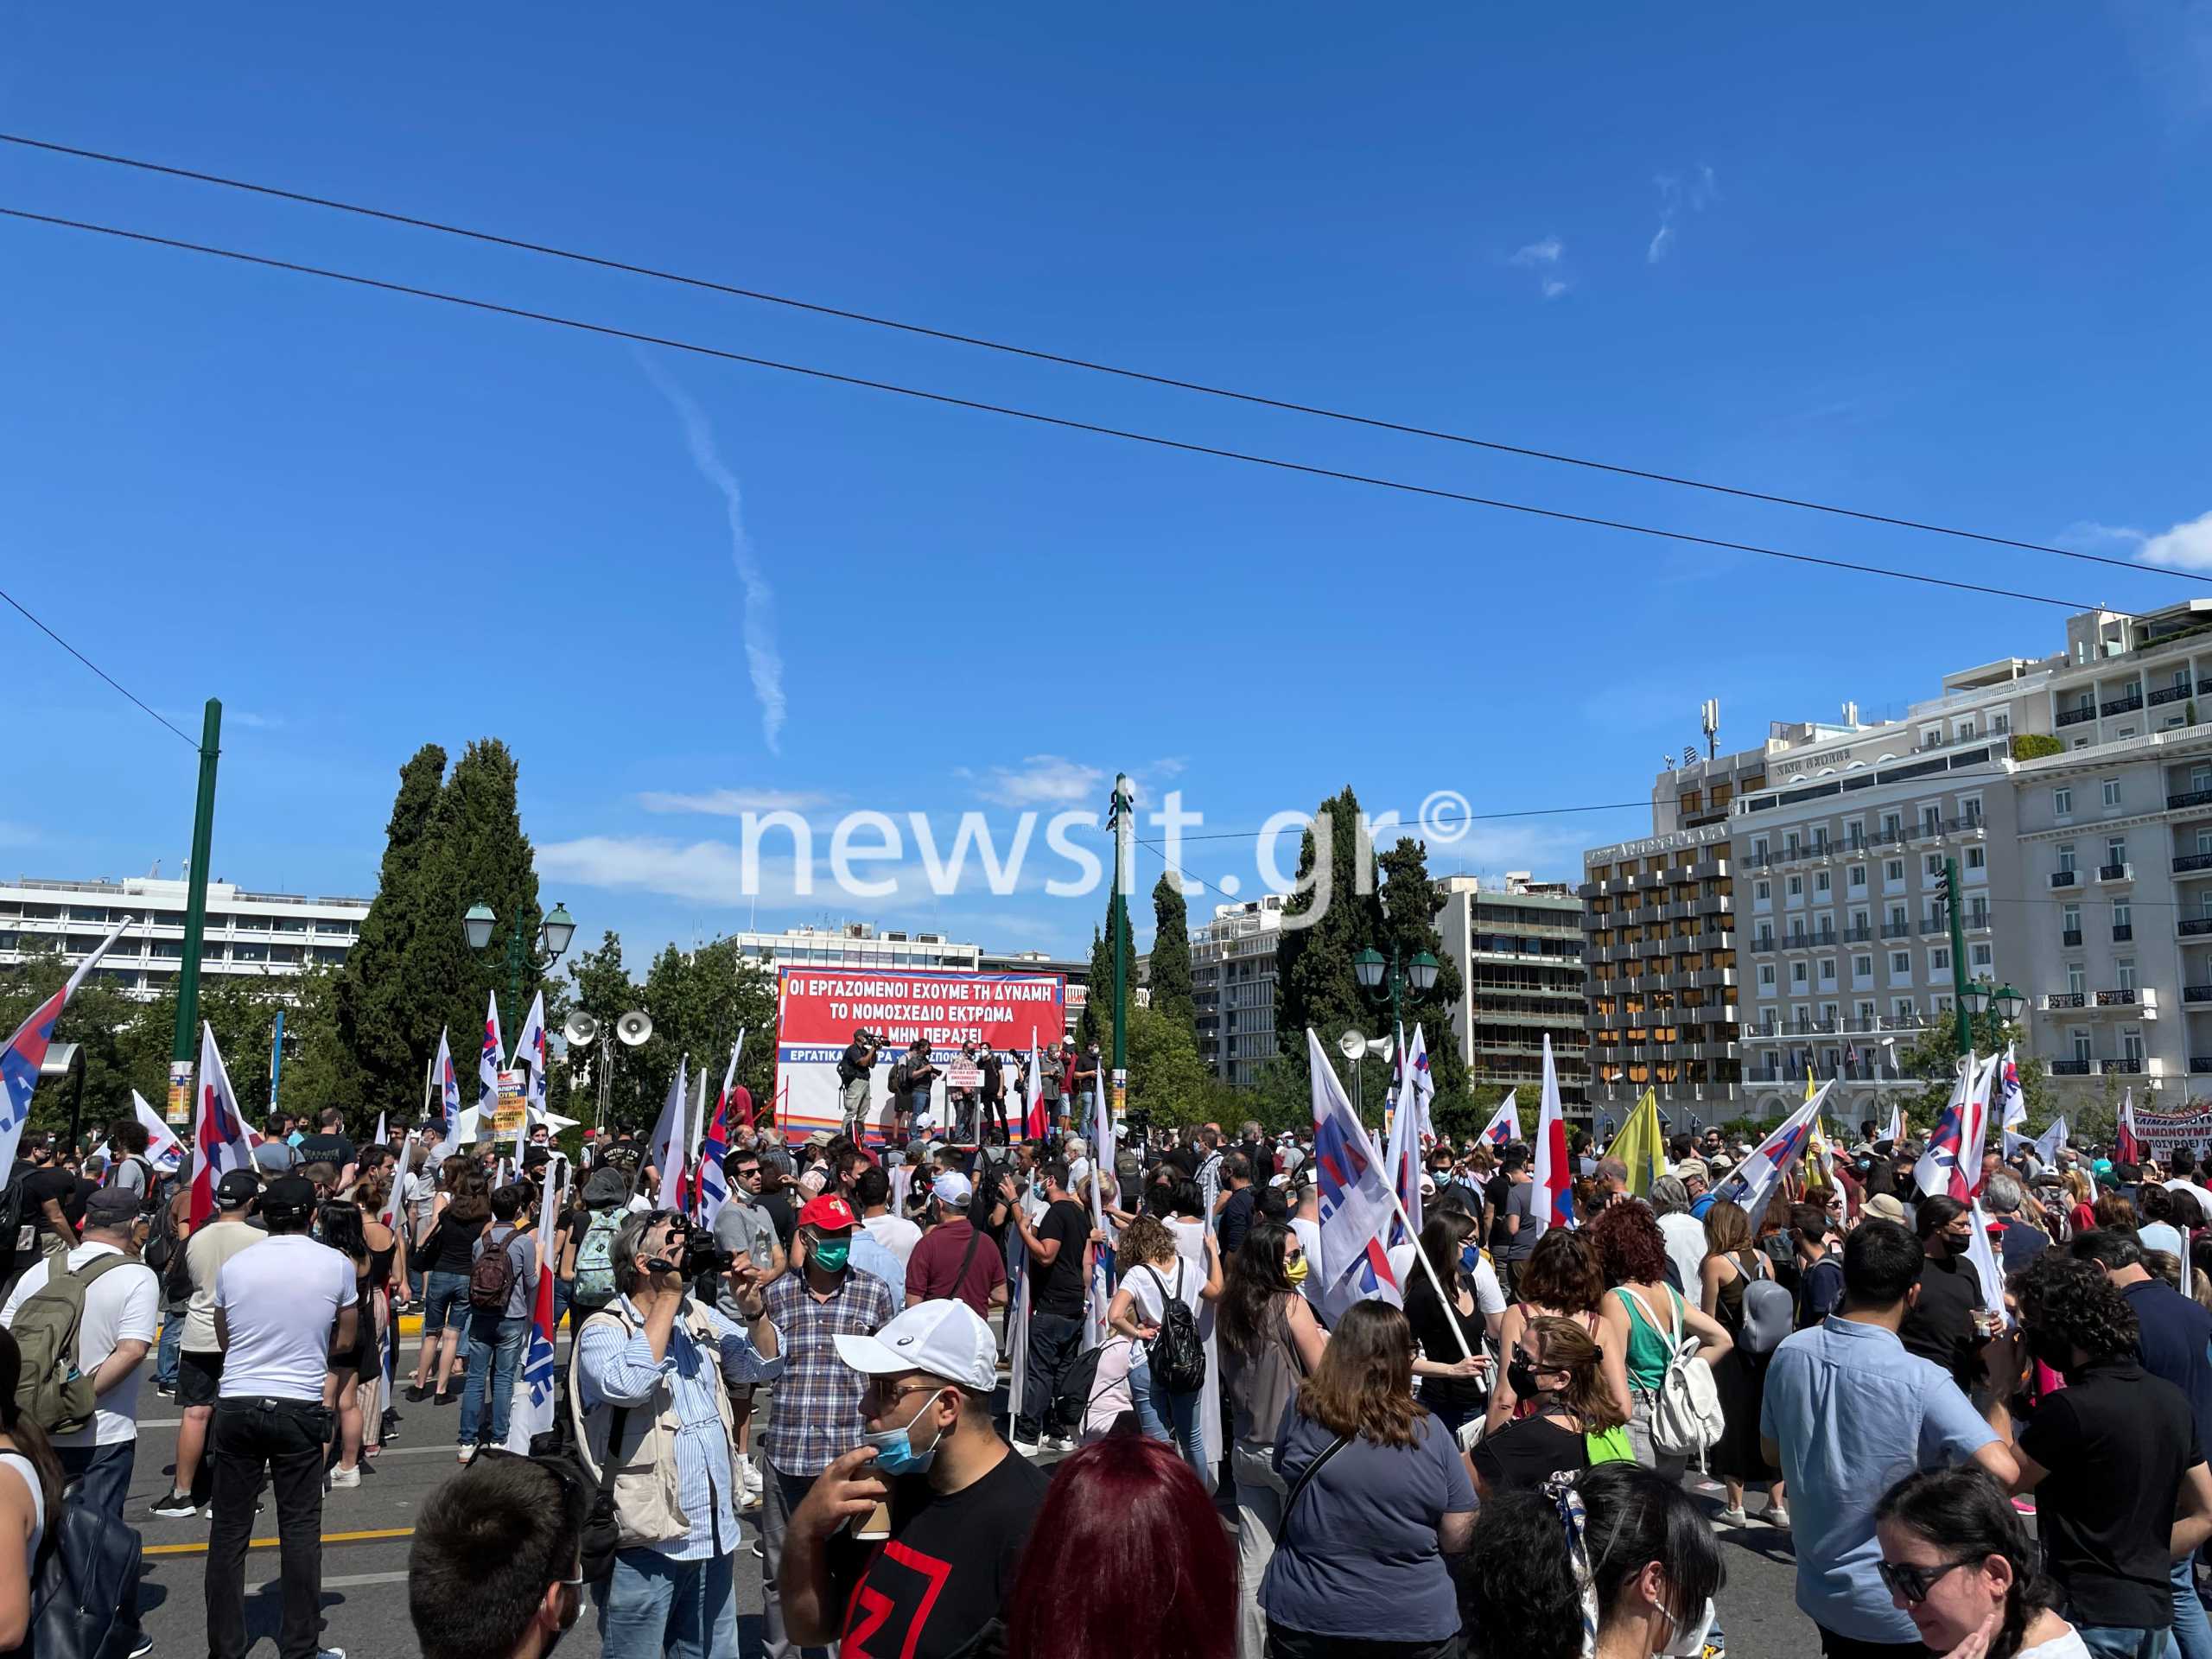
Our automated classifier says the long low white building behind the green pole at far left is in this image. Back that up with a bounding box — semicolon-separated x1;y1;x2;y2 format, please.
0;876;370;998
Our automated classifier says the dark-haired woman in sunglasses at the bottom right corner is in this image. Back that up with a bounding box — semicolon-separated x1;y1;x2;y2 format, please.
1873;1465;2090;1659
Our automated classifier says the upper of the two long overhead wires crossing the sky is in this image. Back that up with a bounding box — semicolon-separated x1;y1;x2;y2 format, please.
0;133;2177;582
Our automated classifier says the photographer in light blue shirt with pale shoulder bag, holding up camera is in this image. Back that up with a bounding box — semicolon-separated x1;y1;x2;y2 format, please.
569;1210;783;1659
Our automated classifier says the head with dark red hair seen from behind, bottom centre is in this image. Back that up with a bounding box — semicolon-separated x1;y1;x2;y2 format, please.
1007;1433;1236;1659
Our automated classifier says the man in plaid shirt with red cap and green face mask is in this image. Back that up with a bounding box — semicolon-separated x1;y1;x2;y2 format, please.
761;1192;898;1659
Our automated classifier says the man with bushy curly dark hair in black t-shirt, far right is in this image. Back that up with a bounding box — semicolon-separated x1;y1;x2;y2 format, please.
2013;1249;2212;1652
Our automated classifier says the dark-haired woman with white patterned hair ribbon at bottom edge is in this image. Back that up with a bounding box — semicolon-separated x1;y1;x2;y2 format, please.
1460;1462;1726;1659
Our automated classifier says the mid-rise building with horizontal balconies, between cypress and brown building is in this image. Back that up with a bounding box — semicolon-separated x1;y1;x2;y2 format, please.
1435;869;1588;1117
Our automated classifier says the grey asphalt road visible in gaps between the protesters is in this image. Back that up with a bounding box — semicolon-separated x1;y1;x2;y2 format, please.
128;1338;1818;1659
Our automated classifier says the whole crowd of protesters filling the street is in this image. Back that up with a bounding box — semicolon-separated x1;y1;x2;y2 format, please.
13;1065;2212;1659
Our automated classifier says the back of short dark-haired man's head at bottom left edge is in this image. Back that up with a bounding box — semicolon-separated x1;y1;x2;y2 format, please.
407;1451;586;1659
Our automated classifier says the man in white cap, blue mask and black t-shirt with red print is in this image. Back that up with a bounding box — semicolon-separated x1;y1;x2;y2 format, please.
779;1300;1048;1659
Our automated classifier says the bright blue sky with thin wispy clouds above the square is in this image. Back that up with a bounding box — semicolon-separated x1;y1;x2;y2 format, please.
0;0;2212;953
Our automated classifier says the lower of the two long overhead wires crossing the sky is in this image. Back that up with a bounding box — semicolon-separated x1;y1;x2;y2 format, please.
0;206;2108;611
